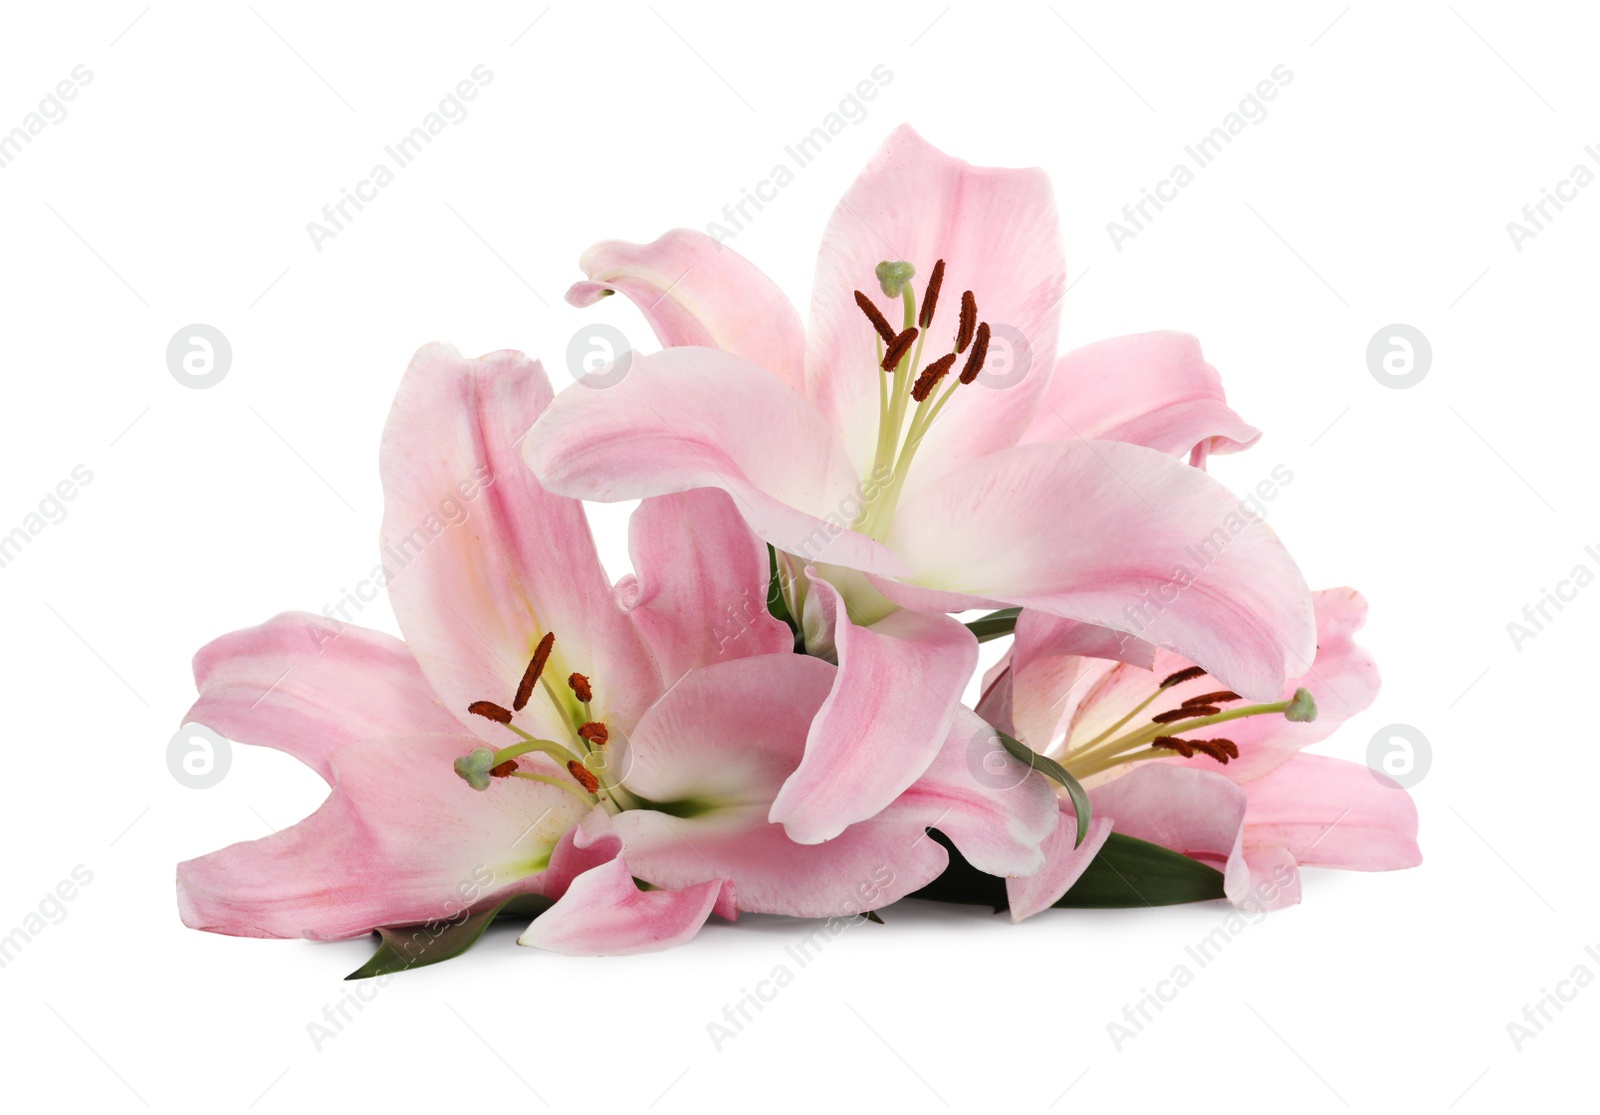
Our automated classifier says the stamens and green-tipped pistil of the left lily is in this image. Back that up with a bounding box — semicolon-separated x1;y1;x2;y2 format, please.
456;632;638;813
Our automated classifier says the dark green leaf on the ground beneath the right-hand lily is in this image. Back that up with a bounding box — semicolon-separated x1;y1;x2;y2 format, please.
912;832;1222;913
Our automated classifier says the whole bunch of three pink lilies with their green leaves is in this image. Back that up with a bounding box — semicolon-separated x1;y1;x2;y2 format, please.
178;126;1419;976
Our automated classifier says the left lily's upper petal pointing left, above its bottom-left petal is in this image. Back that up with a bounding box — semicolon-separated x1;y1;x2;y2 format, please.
182;611;461;779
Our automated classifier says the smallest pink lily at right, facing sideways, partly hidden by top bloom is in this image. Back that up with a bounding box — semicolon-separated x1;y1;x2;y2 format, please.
979;589;1422;910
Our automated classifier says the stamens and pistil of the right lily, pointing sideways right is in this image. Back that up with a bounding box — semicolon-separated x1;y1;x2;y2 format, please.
1061;665;1317;781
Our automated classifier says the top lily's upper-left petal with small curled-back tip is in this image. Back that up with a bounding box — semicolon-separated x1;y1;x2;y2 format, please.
566;229;805;392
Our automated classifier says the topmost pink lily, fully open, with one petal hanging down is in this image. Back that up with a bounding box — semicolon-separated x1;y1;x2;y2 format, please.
528;126;1314;843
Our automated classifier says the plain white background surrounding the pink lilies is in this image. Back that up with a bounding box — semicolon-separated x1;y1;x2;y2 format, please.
0;0;1600;1112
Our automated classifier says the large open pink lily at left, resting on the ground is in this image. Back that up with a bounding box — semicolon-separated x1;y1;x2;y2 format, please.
178;346;1058;953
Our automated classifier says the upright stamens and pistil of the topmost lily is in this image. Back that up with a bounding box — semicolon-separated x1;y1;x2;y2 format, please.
853;259;989;542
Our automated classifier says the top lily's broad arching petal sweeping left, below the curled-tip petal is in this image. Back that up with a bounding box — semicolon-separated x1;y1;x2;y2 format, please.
526;349;906;576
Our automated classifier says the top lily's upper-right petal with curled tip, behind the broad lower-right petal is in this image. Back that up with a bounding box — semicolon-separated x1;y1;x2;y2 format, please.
1022;333;1261;464
